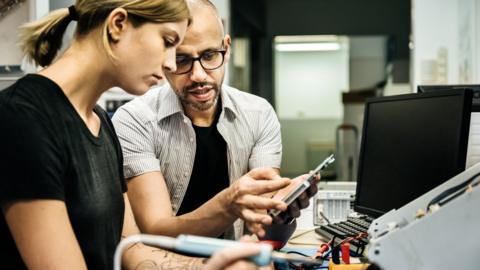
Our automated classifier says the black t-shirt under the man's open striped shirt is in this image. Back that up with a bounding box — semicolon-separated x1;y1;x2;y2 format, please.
177;104;230;221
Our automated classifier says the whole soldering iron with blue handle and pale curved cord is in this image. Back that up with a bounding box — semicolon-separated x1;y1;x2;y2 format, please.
114;234;323;270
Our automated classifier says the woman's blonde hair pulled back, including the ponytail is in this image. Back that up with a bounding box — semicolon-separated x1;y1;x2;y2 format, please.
20;0;191;66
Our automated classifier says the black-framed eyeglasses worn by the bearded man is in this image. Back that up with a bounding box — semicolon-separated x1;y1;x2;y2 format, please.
173;49;227;75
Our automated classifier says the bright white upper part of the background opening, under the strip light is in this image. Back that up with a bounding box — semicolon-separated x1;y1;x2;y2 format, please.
275;43;349;119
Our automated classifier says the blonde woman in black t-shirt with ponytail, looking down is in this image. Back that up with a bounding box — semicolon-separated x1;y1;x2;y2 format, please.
0;0;266;269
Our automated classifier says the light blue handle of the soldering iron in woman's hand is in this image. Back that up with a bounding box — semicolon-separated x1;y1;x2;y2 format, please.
175;234;272;266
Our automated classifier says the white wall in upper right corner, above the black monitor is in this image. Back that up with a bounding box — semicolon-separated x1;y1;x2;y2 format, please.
411;0;480;88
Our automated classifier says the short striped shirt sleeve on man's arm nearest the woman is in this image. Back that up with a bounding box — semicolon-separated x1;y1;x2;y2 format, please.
112;104;160;179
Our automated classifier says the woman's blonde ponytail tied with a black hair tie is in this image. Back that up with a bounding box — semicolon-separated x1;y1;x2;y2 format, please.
20;6;78;67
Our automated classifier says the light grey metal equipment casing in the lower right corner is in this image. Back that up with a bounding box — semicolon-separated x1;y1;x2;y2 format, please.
368;163;480;270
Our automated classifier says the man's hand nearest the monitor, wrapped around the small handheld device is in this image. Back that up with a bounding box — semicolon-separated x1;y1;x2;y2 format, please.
272;174;320;224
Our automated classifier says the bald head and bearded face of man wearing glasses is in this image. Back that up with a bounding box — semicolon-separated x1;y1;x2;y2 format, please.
166;0;231;102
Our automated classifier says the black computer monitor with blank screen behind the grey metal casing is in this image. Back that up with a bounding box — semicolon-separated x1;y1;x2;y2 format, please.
354;89;472;217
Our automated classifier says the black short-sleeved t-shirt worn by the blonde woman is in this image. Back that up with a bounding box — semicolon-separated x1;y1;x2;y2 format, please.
0;74;126;269
